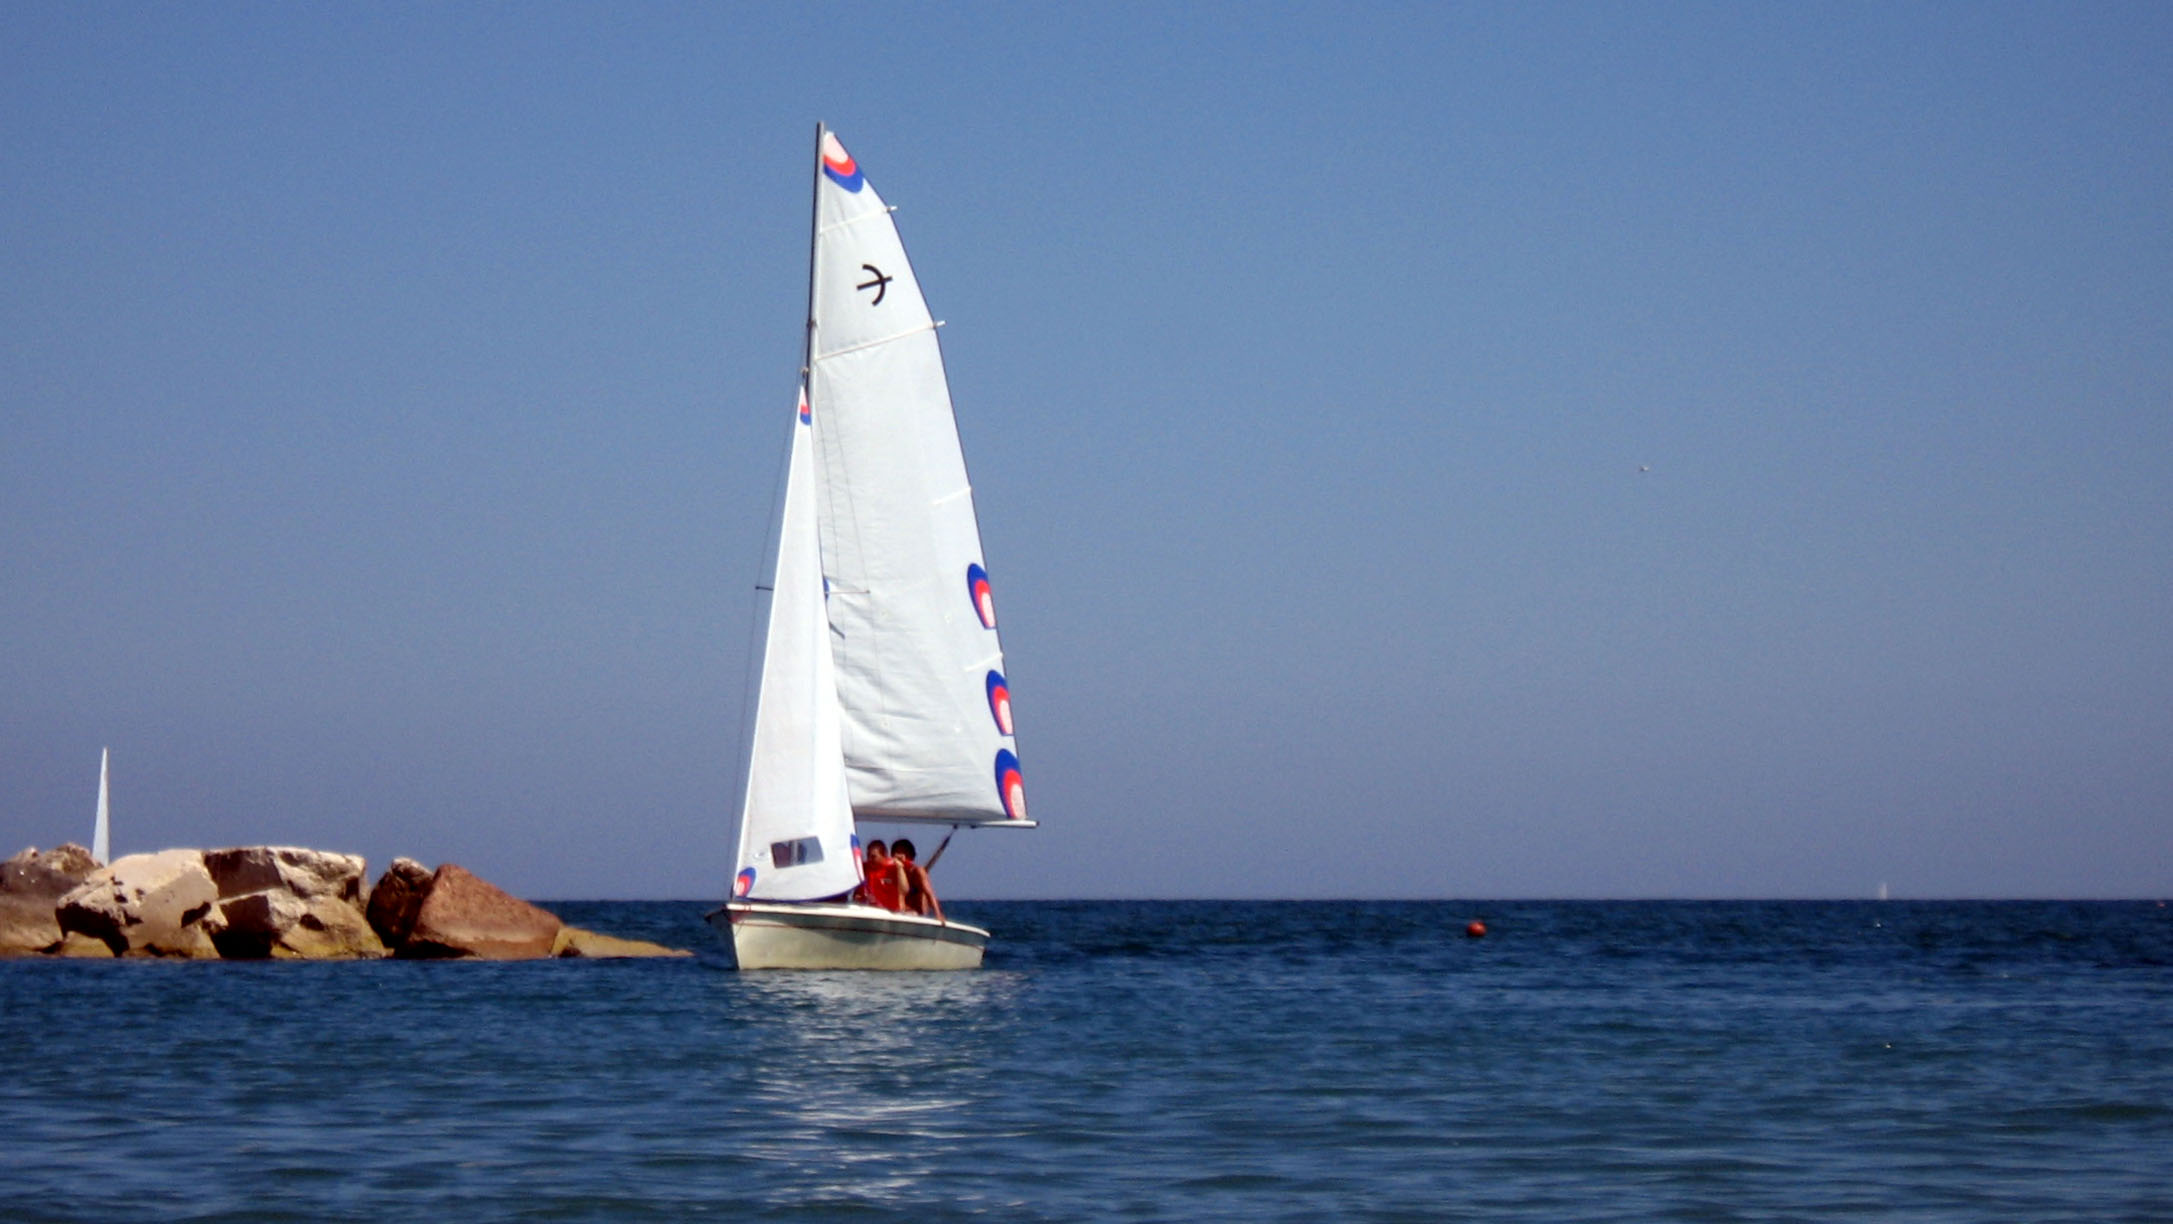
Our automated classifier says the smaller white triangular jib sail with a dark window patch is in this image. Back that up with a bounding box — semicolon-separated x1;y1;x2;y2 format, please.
732;391;861;900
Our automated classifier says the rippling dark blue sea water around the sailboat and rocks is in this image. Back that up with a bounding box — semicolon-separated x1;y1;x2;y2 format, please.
0;900;2173;1222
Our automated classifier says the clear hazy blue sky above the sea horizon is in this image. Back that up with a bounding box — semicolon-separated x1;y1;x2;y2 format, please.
0;4;2173;898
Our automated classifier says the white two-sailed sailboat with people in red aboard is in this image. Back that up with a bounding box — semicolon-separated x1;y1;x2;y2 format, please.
708;126;1034;970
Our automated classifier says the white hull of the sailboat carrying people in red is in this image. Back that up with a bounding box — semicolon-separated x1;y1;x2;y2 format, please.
708;900;989;970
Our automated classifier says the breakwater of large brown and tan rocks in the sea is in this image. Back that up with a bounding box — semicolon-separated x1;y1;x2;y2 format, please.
0;846;687;961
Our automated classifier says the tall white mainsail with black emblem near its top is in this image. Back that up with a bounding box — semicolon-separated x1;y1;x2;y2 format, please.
808;133;1026;824
